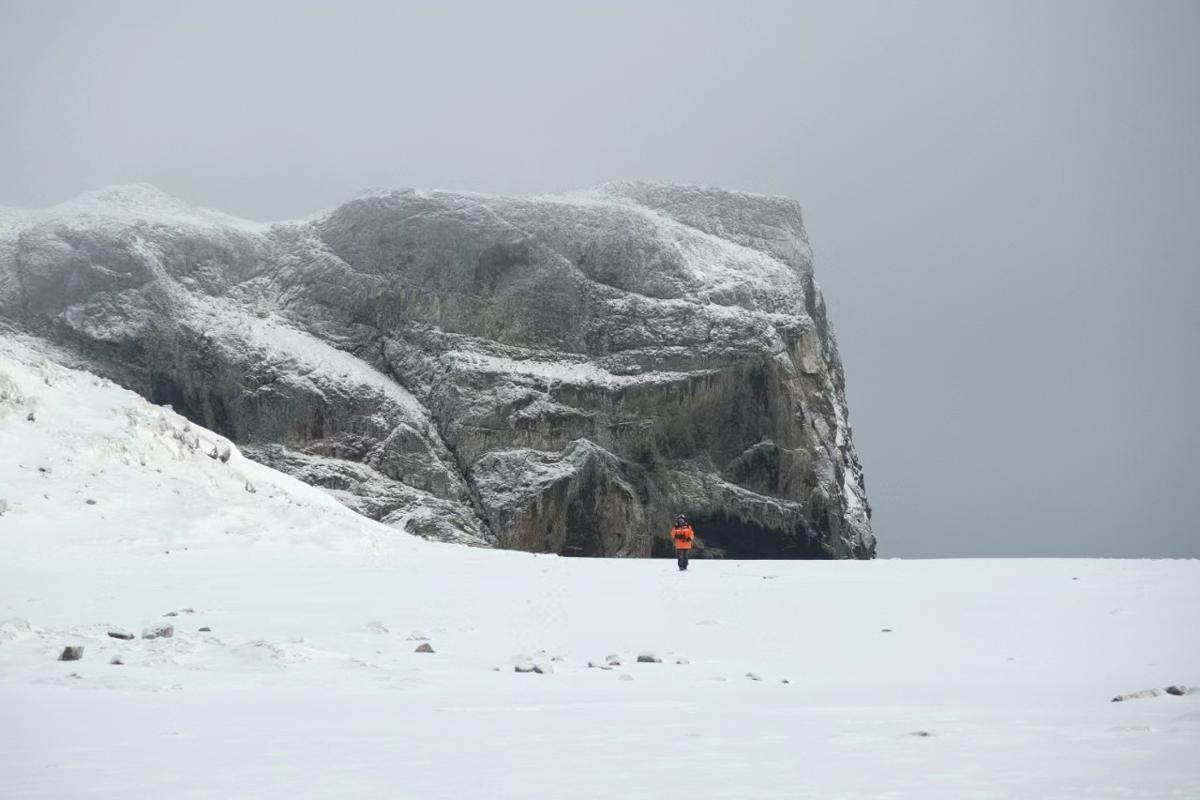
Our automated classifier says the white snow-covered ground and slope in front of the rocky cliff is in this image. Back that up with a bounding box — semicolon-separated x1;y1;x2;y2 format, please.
0;337;1200;800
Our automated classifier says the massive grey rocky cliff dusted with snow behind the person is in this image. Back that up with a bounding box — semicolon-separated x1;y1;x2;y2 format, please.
0;184;875;558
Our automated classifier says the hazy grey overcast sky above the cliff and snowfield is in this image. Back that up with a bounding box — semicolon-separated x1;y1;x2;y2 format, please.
0;0;1200;557
